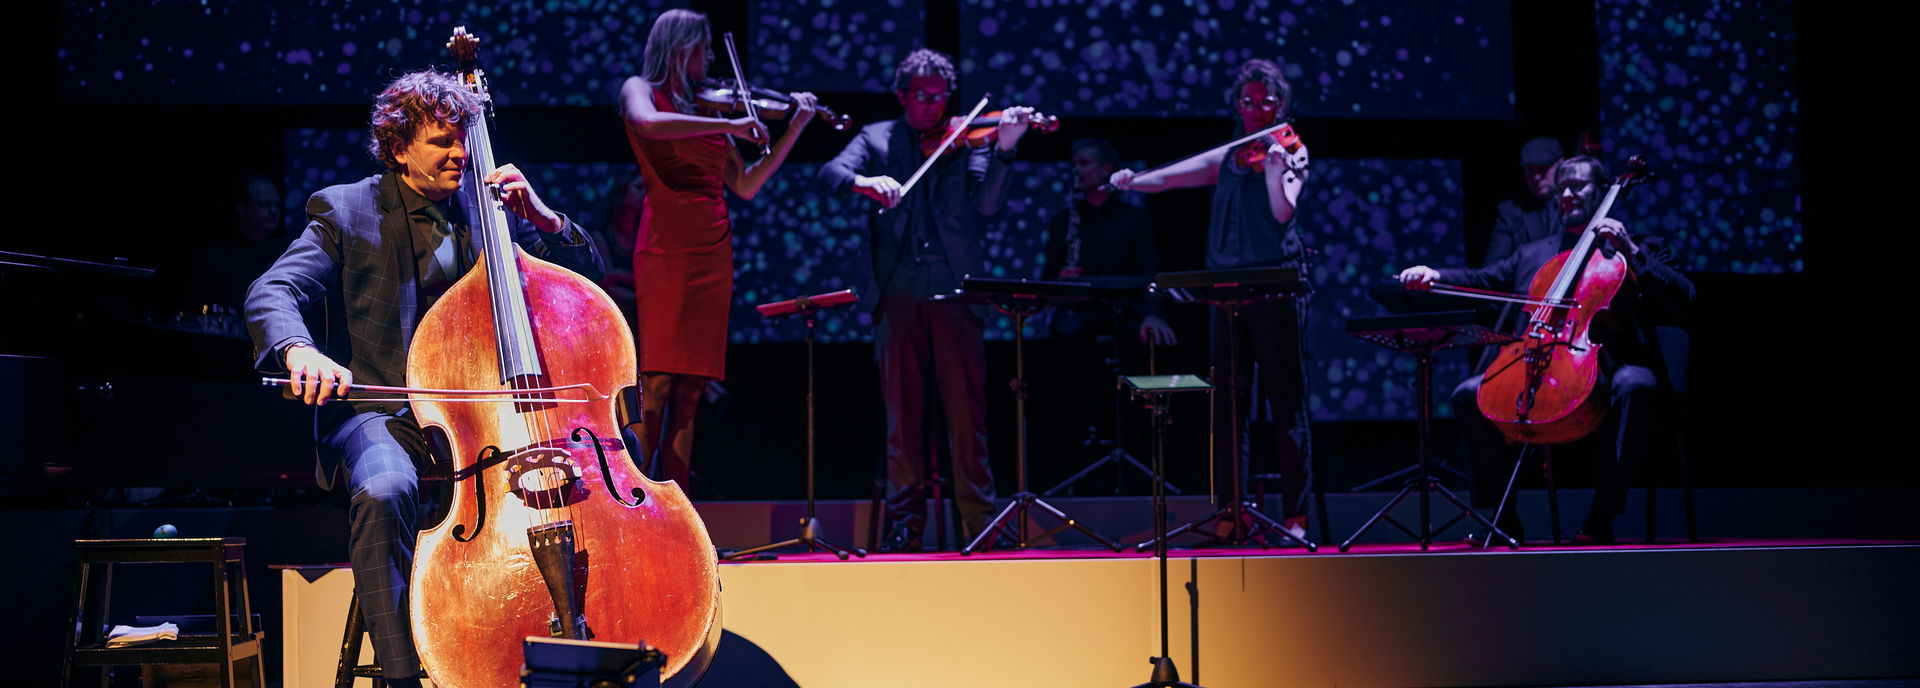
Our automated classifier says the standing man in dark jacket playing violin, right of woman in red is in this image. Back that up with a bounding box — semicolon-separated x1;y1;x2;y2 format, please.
820;48;1033;550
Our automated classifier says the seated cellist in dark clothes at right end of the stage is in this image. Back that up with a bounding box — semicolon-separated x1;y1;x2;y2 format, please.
1398;156;1693;544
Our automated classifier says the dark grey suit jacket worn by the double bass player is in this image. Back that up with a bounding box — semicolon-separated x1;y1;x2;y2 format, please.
246;175;601;486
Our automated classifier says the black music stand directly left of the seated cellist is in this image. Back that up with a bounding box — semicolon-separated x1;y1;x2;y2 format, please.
1340;311;1521;552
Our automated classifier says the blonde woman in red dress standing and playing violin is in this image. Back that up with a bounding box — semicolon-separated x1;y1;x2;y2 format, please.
620;10;814;488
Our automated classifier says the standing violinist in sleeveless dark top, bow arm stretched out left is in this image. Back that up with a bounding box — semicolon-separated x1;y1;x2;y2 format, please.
1112;58;1313;538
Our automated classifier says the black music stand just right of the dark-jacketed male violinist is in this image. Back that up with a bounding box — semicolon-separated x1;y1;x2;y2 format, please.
935;277;1119;555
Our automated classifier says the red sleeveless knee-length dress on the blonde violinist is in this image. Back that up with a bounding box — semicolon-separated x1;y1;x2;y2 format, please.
626;88;733;379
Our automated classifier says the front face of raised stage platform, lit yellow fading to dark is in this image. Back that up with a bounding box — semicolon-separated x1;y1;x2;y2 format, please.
282;546;1920;688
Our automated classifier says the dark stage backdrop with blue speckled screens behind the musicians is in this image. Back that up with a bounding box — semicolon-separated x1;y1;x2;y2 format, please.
15;0;1896;676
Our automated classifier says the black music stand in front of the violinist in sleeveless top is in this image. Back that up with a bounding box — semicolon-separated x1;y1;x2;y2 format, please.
1133;267;1327;552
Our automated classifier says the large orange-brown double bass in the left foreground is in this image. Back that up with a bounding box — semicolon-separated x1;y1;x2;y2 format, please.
407;27;720;688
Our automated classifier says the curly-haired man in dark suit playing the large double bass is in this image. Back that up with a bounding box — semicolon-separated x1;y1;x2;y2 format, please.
246;71;601;686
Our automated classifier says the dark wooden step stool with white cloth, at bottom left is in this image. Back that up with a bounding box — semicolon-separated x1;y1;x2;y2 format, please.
60;538;265;688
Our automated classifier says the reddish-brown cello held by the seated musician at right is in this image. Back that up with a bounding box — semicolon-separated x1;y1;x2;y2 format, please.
1432;158;1647;444
